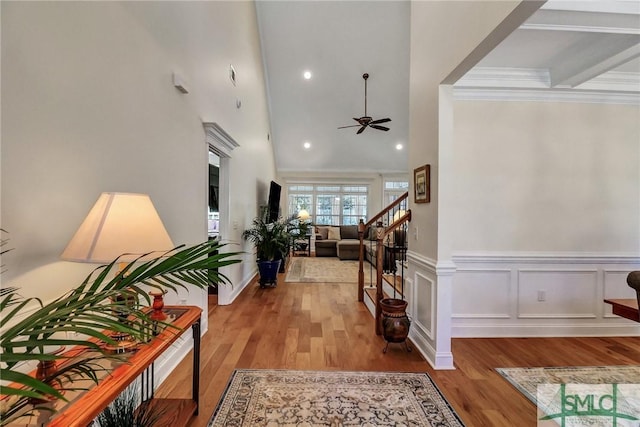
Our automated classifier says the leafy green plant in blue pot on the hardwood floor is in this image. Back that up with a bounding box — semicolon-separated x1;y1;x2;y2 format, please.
242;209;294;287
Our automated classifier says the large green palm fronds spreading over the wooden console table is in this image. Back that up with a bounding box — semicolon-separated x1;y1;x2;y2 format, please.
0;239;240;426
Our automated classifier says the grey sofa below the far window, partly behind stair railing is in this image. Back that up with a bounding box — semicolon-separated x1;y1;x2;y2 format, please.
315;225;391;271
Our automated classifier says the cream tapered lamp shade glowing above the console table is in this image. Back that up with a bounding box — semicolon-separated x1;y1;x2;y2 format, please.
61;193;174;263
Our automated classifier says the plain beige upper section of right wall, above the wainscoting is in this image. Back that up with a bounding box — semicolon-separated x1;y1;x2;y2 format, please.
454;101;640;254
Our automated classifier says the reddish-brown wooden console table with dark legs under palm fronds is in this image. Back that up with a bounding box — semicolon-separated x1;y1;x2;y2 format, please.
11;305;202;427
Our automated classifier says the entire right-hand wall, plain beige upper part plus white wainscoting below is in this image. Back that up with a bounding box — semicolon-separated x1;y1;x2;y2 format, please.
453;101;640;336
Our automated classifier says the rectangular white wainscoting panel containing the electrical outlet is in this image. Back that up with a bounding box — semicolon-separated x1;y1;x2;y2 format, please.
518;269;598;319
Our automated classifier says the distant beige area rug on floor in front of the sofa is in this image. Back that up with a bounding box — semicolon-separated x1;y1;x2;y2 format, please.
284;257;370;283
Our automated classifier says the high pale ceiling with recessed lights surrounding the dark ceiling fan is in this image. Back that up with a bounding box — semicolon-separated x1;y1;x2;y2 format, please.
256;1;410;172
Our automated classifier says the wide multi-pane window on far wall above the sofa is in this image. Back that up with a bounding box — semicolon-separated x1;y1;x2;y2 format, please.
289;184;369;225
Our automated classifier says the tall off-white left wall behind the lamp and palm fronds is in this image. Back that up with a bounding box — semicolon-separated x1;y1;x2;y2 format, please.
0;2;275;384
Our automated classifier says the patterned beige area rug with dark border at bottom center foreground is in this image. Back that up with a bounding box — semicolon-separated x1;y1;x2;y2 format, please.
208;369;463;427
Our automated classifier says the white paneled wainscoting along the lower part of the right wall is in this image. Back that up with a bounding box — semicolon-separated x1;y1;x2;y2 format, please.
451;253;640;337
